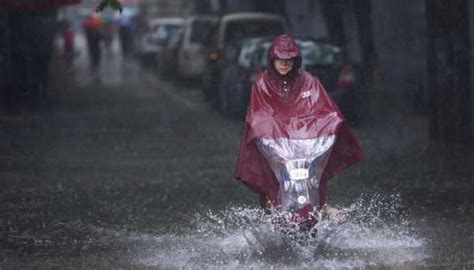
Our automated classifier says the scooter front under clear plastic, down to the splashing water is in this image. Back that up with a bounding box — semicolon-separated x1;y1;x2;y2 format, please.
257;135;336;236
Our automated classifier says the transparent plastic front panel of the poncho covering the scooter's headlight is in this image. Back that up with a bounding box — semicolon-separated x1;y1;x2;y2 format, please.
257;135;336;211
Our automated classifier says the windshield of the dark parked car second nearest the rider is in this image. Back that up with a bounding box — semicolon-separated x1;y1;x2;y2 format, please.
224;19;284;44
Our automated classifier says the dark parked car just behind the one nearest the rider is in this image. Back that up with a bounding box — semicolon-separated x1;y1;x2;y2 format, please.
202;12;287;101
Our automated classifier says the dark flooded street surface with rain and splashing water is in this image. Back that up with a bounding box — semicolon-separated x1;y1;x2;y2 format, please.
0;36;474;269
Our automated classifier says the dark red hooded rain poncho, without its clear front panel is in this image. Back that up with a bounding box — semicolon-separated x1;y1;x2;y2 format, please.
235;35;362;207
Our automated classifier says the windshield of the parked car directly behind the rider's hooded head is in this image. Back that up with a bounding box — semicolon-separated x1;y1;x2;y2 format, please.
256;39;342;67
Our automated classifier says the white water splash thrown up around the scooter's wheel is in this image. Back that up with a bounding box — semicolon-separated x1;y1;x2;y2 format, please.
138;194;427;269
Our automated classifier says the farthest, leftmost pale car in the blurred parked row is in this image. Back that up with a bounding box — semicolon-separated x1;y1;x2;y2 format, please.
136;18;185;66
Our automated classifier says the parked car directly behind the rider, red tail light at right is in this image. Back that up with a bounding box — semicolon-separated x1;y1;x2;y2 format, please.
218;35;359;124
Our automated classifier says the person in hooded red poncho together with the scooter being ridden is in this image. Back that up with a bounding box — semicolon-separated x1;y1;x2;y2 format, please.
235;35;362;232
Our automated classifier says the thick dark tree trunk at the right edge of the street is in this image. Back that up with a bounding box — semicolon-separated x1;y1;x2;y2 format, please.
425;0;472;142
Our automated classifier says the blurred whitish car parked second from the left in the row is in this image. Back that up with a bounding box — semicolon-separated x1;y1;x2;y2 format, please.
177;16;218;78
